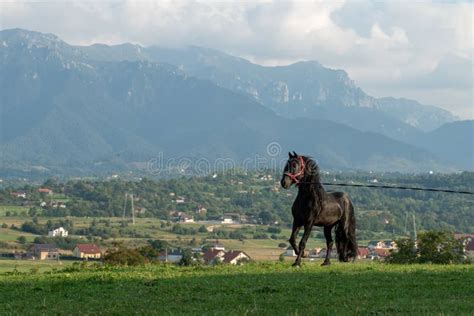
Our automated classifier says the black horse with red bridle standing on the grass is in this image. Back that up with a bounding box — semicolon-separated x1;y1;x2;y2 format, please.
281;152;357;266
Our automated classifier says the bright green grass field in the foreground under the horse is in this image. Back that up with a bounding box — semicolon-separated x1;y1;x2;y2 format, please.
0;263;474;315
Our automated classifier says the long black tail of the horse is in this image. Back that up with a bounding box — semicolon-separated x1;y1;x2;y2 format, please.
336;195;358;262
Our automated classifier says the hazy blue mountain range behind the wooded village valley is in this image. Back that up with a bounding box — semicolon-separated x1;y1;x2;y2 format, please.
0;29;474;172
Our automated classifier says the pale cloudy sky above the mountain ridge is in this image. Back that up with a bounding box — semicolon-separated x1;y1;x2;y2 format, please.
0;0;474;119
